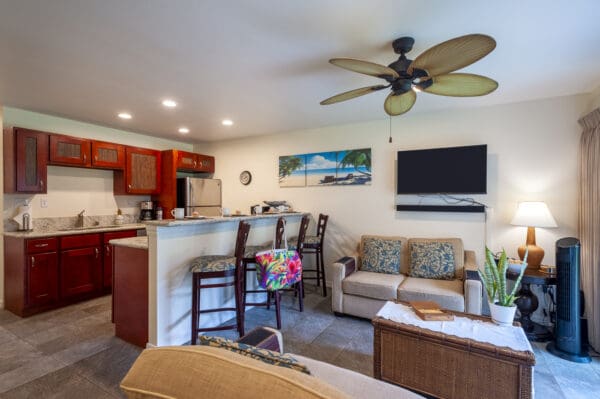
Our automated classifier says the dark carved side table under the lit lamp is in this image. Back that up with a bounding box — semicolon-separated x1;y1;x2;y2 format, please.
506;268;556;342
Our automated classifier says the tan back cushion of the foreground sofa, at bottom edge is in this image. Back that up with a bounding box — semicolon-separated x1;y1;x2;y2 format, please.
121;346;349;399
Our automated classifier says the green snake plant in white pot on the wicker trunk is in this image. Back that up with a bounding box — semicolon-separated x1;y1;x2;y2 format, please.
477;247;527;326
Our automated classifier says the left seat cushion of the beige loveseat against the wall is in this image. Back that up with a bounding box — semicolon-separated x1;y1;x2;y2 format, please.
342;270;406;301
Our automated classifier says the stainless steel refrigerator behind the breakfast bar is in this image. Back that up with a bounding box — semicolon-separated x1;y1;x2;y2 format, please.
177;177;221;216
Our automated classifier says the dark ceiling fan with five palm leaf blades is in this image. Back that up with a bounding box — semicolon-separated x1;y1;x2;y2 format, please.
321;34;498;116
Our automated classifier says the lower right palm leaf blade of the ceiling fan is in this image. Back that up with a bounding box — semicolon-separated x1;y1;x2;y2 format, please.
423;73;498;97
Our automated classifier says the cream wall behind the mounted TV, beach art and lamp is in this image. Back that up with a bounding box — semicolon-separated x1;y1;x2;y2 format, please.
197;95;589;276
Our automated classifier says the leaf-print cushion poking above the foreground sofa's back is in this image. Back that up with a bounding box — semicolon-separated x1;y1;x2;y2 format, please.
200;335;310;374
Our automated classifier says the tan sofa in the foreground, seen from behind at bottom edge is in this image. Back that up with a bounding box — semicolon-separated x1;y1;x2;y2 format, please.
121;346;421;399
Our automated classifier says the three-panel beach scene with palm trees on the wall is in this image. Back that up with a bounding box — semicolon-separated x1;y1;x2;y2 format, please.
279;148;371;187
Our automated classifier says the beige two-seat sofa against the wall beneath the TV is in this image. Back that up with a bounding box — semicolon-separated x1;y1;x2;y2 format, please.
332;236;482;319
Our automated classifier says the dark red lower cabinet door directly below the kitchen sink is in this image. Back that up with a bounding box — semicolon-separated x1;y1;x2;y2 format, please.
60;247;102;298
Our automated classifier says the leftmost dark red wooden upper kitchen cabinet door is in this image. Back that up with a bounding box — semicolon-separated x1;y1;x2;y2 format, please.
15;128;48;193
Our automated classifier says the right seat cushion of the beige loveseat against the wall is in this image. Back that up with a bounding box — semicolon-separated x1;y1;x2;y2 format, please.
398;277;465;312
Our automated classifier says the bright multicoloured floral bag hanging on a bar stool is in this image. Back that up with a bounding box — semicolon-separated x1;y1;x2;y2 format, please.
256;249;302;291
